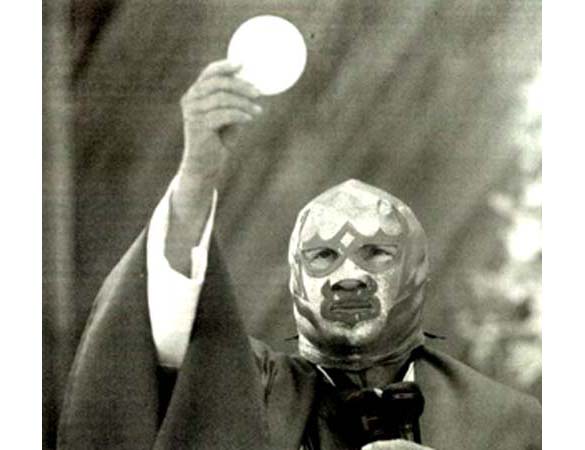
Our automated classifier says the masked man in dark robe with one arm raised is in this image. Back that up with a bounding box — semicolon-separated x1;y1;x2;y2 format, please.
59;61;540;450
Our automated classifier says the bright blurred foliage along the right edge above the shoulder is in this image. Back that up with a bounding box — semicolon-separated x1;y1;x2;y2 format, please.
457;75;542;397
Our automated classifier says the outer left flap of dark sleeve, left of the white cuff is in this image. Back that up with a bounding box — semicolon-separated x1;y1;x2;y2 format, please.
58;232;159;449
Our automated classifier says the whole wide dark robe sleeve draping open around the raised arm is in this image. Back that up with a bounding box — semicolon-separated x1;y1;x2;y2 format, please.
58;229;268;450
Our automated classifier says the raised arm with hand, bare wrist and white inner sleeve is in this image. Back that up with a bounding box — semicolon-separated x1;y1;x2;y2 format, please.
147;61;261;368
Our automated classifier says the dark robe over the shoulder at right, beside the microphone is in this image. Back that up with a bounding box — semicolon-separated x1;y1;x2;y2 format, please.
415;347;542;449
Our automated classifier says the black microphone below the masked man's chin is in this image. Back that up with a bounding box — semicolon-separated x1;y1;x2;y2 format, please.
343;382;424;447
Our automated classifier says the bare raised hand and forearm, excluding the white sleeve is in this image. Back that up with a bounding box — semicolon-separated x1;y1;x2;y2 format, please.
165;60;262;276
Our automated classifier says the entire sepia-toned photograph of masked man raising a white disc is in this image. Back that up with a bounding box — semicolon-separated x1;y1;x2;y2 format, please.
42;0;543;450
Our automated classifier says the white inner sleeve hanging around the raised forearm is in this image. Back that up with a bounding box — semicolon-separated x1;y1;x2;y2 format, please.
146;179;217;368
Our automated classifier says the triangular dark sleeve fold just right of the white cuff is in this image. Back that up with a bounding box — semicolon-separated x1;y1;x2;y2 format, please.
149;236;269;450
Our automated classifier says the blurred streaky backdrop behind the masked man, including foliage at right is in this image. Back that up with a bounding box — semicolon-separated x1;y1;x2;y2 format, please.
43;0;541;448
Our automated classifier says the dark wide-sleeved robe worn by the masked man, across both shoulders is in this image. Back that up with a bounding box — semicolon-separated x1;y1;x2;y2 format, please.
58;233;541;450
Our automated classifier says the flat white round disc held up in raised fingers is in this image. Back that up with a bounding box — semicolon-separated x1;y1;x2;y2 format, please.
227;15;307;95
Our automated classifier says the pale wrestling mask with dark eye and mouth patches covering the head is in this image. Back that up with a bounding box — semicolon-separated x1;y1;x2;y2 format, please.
289;180;428;370
